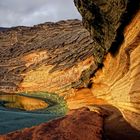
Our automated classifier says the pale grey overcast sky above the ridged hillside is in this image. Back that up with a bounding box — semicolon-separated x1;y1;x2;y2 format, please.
0;0;81;27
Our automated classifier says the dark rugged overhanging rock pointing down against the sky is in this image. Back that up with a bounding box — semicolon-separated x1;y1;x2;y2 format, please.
74;0;140;63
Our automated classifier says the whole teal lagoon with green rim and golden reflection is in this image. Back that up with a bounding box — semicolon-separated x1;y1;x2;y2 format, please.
0;92;68;134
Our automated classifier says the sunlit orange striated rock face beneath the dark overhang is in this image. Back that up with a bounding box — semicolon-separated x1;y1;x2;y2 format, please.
92;12;140;130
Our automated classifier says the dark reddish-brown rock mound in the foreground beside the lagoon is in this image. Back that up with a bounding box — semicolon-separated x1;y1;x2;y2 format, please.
0;108;103;140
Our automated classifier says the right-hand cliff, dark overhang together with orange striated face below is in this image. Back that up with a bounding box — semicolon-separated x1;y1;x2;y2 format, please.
75;0;140;130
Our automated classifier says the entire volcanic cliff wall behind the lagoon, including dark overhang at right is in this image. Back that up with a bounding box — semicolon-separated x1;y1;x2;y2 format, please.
0;0;140;140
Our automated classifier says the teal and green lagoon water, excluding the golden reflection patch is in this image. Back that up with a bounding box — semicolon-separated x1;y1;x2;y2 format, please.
0;92;67;134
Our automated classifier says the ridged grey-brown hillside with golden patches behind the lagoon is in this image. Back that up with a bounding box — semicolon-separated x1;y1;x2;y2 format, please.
0;20;97;95
